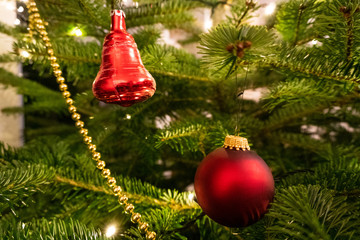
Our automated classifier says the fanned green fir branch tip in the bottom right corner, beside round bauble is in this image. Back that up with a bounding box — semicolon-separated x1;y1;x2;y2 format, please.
269;185;360;239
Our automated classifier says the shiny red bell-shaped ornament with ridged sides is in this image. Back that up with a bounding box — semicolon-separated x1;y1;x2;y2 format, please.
93;10;156;107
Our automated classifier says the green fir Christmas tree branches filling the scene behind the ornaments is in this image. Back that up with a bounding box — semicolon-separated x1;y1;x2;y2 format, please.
0;0;360;240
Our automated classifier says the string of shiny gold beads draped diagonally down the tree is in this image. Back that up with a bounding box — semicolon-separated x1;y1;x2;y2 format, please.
27;0;156;240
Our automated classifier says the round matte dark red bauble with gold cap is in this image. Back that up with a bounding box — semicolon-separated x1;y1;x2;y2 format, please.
195;136;275;227
